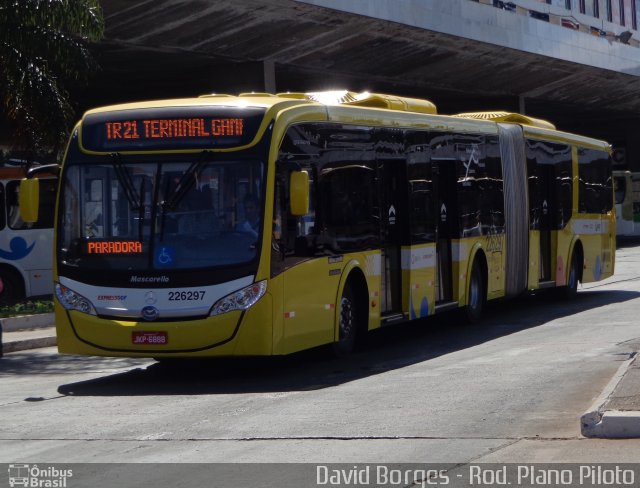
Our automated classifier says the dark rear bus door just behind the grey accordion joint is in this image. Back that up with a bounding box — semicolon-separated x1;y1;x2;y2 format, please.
537;164;558;282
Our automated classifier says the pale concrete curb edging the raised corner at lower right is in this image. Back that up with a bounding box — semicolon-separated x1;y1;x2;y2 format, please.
580;353;640;439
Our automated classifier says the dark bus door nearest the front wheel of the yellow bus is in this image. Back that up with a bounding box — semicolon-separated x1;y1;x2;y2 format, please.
378;158;408;318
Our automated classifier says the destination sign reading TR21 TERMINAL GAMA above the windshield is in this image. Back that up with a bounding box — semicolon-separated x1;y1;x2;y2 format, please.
81;106;264;152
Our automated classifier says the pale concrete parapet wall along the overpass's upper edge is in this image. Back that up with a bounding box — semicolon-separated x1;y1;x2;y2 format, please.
296;0;640;76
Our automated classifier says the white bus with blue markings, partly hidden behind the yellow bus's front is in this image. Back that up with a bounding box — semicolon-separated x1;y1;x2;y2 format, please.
0;166;58;304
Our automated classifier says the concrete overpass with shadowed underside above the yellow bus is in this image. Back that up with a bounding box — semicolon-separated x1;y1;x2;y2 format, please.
92;0;640;166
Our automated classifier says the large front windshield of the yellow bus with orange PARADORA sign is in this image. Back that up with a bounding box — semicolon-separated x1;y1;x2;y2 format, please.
58;153;264;271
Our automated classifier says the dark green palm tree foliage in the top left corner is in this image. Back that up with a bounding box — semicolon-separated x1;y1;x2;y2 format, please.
0;0;104;159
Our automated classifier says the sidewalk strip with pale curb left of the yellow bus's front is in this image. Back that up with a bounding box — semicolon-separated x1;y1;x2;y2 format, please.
0;313;56;356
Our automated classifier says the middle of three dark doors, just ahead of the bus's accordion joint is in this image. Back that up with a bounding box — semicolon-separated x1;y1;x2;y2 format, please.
432;159;458;305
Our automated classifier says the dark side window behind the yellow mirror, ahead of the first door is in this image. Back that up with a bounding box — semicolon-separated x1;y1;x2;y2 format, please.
274;124;379;257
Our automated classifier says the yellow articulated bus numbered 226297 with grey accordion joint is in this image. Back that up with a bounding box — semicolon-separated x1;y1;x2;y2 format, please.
21;92;615;358
